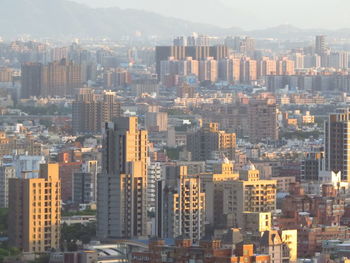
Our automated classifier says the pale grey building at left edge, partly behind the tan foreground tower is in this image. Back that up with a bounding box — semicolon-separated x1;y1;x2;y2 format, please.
0;165;16;208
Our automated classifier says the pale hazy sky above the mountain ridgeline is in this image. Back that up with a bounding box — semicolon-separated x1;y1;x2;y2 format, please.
71;0;350;29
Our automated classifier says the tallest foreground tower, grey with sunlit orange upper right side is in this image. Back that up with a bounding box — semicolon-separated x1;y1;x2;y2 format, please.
97;117;148;239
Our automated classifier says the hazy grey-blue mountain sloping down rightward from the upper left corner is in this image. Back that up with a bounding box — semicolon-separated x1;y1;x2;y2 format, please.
0;0;240;39
